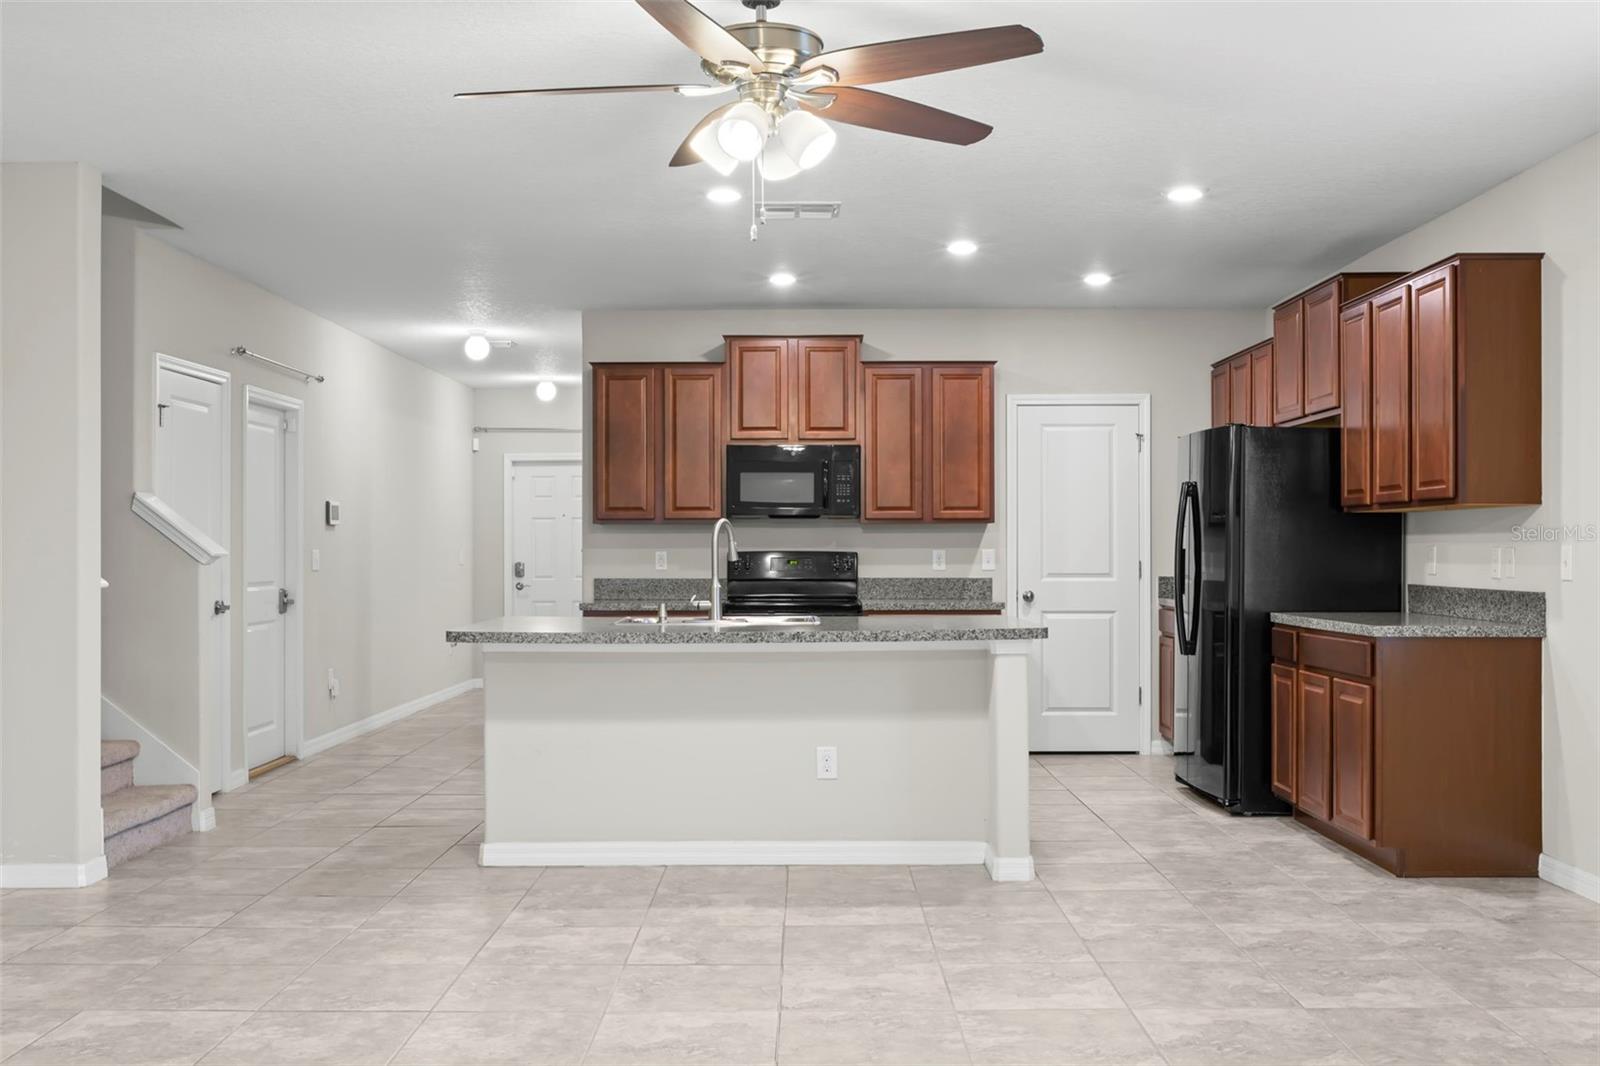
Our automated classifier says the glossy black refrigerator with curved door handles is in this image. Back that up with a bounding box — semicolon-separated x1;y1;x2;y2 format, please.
1173;426;1405;815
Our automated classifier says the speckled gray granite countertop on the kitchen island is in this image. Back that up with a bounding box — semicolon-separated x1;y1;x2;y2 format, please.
445;615;1048;645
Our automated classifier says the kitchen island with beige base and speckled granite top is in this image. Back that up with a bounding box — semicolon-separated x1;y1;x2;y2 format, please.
446;616;1045;880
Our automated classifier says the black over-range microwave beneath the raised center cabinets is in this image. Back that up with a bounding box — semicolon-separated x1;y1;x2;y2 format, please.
723;445;861;519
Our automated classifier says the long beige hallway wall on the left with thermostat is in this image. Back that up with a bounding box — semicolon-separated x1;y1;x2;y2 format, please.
104;221;472;773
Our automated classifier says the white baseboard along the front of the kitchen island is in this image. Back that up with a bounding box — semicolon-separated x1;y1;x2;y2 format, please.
478;840;992;868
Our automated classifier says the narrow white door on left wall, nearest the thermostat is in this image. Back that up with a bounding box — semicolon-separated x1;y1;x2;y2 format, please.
243;402;294;767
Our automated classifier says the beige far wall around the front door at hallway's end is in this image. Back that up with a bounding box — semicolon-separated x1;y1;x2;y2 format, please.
472;386;582;621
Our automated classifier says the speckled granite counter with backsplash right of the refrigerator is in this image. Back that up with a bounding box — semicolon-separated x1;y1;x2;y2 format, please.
1272;584;1544;639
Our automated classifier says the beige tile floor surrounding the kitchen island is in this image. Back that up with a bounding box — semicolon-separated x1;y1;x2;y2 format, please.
0;695;1600;1066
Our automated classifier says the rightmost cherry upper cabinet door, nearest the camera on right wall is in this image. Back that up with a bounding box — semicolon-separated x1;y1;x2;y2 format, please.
1411;266;1456;501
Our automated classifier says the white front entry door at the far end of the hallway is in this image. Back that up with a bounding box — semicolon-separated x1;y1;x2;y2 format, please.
506;463;584;616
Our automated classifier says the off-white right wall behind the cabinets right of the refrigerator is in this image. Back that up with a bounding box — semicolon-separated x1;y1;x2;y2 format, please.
1349;130;1600;877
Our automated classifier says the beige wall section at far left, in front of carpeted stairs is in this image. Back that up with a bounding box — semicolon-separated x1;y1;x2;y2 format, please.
0;163;104;884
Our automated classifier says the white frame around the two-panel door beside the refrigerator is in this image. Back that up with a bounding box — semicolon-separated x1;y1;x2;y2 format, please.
1005;392;1160;755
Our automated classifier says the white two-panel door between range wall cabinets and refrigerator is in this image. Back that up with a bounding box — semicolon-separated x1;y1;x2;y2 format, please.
1011;403;1147;751
